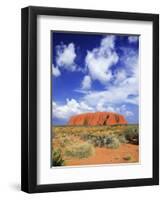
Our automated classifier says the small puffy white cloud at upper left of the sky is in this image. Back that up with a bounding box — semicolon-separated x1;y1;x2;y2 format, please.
56;43;77;71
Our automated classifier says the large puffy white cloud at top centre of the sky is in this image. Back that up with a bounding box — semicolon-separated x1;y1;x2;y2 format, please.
85;35;119;84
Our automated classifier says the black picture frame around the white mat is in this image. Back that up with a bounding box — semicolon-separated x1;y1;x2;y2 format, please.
21;6;159;193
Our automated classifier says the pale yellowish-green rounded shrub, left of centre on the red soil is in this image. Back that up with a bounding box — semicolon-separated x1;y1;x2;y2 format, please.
65;142;94;158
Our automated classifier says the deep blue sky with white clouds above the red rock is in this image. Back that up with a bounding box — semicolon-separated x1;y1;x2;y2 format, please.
52;32;139;125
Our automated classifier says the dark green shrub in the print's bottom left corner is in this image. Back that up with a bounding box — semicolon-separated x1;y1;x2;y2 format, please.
52;149;64;166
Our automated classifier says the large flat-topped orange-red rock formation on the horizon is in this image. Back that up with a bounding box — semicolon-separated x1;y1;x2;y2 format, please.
68;112;127;126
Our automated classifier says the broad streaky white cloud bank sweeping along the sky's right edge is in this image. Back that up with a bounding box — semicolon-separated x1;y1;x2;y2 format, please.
83;45;139;106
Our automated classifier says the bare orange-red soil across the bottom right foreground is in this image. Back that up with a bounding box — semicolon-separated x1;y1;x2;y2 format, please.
66;144;139;166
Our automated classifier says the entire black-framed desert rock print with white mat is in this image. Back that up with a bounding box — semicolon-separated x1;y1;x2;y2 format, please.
21;6;159;193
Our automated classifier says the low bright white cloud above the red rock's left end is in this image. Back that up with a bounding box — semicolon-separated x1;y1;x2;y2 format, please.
52;99;94;120
